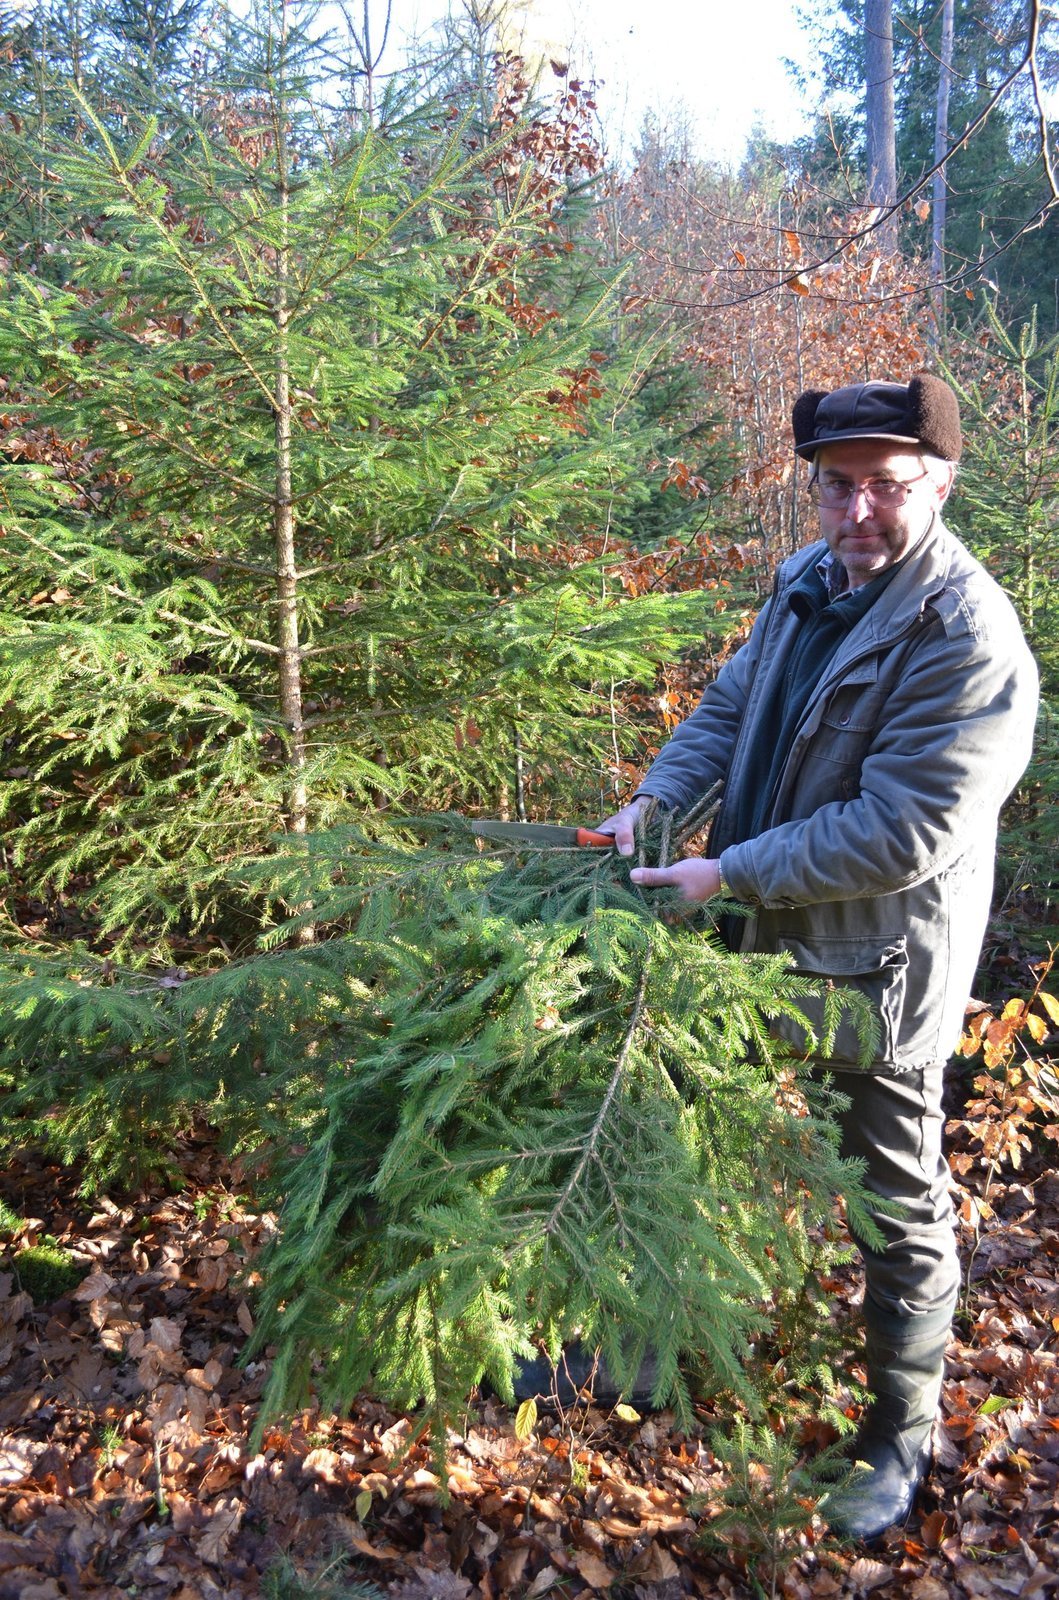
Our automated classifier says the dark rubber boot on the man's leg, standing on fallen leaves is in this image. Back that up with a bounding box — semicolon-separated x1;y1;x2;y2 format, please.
829;1301;953;1539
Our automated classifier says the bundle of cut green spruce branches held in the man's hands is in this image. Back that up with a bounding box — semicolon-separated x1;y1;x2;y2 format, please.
235;808;889;1429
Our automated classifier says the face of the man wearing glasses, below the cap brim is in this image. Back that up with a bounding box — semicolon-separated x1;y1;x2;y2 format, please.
816;438;952;589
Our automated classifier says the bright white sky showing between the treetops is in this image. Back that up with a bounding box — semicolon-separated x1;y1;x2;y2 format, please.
394;0;808;163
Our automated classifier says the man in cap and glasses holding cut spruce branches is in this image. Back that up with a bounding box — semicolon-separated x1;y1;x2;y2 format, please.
601;374;1037;1539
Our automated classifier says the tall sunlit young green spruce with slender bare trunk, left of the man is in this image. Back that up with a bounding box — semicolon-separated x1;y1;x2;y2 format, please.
0;6;723;962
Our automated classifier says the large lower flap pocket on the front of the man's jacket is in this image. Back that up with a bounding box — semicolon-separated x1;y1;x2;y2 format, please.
774;933;909;1072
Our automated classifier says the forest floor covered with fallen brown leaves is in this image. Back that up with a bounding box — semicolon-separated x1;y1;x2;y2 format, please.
0;1062;1059;1600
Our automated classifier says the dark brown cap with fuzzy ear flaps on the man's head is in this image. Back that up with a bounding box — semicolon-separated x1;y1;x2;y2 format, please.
790;373;961;461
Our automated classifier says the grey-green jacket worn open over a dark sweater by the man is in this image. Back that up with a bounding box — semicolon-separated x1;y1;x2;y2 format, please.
638;518;1037;1070
